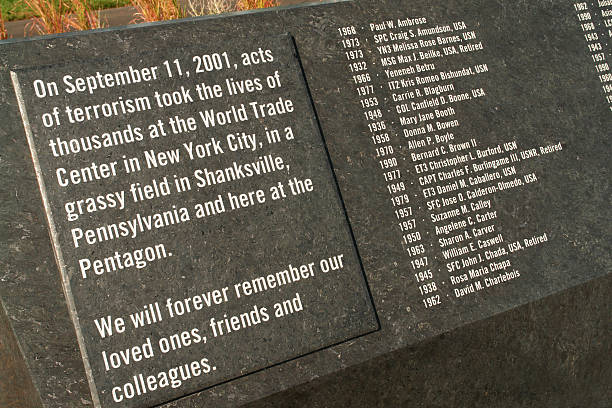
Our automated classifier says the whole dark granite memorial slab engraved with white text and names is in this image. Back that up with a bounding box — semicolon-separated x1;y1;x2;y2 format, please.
0;0;612;407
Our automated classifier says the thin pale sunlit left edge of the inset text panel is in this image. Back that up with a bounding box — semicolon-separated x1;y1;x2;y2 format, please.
11;71;102;408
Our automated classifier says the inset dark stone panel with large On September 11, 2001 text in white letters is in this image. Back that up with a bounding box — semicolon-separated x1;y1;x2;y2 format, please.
11;36;378;407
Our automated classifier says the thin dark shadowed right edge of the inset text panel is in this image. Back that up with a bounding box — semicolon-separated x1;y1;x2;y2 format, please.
285;32;382;330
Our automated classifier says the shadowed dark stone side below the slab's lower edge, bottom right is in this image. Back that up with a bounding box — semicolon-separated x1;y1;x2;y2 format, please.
245;276;612;408
